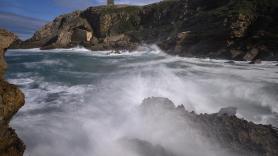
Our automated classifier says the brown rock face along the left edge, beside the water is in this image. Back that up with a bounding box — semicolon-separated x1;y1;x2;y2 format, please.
0;29;25;156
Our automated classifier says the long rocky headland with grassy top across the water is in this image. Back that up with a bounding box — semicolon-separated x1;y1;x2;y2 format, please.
13;0;278;62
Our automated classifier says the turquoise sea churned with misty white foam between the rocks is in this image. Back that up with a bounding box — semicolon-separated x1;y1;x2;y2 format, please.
6;48;278;156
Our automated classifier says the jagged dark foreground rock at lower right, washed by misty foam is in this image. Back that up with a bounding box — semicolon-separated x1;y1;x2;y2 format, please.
137;97;278;156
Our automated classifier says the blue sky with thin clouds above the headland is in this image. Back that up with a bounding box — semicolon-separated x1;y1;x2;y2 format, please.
0;0;160;40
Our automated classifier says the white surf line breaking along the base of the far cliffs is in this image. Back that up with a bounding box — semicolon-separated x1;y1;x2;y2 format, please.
7;44;278;67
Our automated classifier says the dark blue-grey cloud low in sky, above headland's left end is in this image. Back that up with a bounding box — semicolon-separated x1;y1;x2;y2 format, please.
0;12;47;39
